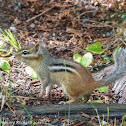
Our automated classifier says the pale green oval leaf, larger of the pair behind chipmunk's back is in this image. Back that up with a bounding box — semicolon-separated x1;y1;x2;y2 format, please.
80;53;93;67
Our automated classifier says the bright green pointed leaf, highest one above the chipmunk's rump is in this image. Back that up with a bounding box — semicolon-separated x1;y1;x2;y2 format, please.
86;42;104;54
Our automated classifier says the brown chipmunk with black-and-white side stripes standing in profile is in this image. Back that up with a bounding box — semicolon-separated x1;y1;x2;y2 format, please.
15;44;126;103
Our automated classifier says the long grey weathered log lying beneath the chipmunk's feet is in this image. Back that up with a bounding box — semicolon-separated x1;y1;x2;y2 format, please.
0;103;126;116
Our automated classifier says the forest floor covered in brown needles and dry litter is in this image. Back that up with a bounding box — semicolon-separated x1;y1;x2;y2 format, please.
0;0;126;126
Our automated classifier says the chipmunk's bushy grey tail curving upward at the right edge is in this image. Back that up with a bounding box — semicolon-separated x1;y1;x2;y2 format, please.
98;48;126;87
